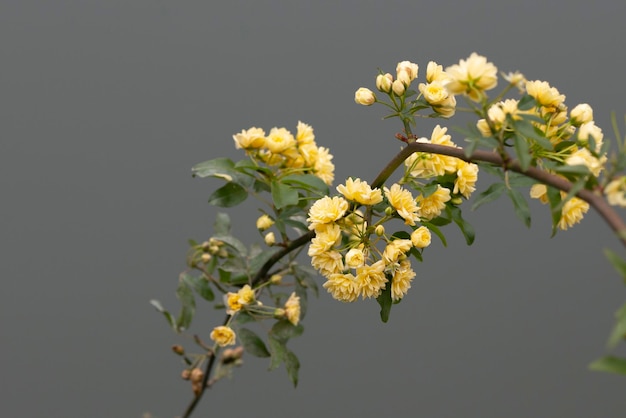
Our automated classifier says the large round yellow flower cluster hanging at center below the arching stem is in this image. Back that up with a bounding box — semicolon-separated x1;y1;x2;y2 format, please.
307;179;434;302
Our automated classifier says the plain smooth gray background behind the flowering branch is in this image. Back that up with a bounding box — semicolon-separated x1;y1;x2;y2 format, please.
0;0;626;418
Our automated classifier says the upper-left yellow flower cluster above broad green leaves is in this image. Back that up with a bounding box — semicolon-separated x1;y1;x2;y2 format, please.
233;122;335;185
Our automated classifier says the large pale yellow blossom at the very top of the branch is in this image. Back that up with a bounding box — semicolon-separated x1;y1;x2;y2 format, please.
446;52;498;101
